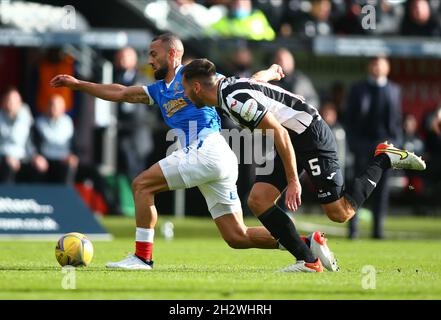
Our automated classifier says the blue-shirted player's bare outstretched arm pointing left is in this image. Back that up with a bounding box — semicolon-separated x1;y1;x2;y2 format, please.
50;75;150;104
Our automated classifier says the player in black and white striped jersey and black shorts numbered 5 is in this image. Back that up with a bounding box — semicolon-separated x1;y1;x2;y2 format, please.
182;59;426;271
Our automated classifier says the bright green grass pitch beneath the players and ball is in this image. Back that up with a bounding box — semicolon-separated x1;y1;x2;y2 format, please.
0;215;441;300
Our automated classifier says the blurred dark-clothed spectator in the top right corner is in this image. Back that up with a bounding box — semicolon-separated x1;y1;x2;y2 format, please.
401;0;441;37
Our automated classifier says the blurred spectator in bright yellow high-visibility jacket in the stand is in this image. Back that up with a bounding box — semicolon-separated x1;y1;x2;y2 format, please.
207;0;276;41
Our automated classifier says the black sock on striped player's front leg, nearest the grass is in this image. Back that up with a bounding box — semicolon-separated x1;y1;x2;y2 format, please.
259;206;316;262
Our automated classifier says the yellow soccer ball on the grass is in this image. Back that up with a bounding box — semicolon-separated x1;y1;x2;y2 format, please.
55;232;93;267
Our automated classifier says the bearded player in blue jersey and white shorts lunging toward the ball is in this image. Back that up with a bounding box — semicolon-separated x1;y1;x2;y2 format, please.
51;34;334;270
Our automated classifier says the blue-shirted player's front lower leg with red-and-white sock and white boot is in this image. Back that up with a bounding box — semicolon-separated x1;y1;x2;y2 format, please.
106;163;169;270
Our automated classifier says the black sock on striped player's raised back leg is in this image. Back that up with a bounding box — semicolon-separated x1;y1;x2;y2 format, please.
344;154;391;211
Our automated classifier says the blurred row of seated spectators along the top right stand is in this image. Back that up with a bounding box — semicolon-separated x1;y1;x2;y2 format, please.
171;0;441;41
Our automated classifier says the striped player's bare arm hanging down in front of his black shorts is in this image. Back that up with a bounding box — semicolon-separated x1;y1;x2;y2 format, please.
257;112;302;211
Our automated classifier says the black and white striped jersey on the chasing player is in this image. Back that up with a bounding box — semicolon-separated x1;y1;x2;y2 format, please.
217;77;320;134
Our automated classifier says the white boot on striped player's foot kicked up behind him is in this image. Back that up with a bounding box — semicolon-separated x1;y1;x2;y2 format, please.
375;141;426;171
